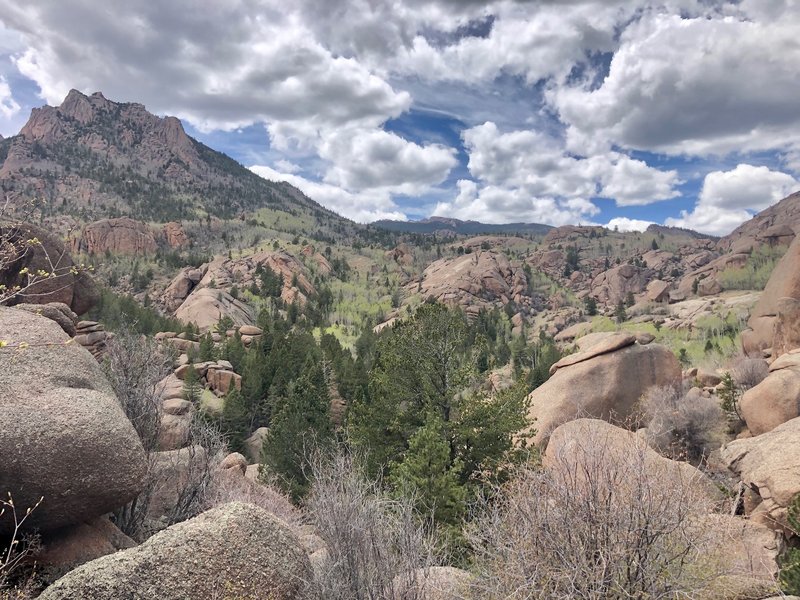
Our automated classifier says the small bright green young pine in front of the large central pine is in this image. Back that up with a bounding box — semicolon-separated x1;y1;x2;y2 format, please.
391;413;466;524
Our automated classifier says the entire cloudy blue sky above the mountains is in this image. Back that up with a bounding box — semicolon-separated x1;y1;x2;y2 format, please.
0;0;800;235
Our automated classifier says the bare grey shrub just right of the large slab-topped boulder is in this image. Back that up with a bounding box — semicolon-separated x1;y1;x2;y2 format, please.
640;386;726;463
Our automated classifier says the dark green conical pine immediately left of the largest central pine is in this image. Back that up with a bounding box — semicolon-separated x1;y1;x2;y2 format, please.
261;360;333;502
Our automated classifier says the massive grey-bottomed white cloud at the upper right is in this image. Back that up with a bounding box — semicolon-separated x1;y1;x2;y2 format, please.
547;13;800;155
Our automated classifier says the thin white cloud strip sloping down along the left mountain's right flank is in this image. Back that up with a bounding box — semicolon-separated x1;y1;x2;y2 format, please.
250;165;405;223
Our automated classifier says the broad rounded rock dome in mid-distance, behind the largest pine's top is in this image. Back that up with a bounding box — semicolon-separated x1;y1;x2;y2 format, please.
408;251;532;313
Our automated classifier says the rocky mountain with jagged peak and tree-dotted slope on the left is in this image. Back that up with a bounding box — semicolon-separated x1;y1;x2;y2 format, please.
0;90;347;224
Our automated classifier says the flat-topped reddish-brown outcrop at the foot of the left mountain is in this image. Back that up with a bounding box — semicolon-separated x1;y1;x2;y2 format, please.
72;217;158;254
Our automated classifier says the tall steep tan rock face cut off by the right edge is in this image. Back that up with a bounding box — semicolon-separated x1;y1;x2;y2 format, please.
742;233;800;354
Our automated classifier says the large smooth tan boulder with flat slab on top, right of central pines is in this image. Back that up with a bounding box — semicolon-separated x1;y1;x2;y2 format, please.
528;344;681;445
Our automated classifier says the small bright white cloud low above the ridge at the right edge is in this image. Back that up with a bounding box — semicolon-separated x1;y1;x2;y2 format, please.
665;164;800;235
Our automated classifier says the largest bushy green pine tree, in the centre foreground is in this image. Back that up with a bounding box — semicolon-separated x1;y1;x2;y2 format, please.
348;303;528;524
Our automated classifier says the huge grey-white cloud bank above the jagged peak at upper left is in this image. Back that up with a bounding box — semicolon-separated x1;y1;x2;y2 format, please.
0;0;411;138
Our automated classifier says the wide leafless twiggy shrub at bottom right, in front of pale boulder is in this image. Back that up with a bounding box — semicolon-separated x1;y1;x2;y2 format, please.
468;430;724;600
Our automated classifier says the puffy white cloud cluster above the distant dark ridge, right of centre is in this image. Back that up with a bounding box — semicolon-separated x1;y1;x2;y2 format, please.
436;122;679;225
